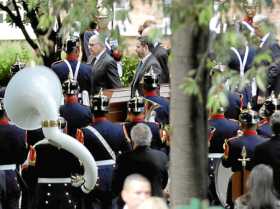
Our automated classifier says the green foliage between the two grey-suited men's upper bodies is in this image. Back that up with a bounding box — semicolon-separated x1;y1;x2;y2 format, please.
121;56;139;87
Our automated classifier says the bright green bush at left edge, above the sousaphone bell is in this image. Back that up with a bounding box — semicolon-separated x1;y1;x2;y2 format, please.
0;41;34;86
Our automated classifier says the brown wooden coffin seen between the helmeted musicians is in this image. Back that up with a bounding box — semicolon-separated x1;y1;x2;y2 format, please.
104;84;170;122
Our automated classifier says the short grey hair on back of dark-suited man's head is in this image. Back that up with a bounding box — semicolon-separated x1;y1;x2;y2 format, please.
130;123;153;146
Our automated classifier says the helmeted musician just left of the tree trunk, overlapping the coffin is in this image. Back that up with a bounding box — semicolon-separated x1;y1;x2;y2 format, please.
143;70;169;124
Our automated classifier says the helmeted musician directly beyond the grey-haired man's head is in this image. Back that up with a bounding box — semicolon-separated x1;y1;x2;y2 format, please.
123;92;165;152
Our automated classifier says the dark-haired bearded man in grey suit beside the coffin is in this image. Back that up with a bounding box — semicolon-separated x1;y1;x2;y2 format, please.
131;37;163;96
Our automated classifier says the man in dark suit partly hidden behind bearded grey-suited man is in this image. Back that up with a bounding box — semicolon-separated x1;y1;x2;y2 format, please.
142;26;170;83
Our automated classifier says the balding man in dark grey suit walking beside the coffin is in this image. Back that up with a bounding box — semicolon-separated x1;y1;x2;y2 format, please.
88;34;121;95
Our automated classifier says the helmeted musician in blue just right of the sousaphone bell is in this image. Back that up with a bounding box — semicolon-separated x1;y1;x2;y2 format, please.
59;79;92;137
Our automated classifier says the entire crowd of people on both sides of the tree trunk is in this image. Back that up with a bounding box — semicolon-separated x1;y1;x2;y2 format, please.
3;0;280;209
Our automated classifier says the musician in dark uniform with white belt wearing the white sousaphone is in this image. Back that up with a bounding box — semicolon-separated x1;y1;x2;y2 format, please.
25;117;82;209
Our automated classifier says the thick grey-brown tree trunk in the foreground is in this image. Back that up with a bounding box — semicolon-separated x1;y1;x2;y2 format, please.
170;0;207;208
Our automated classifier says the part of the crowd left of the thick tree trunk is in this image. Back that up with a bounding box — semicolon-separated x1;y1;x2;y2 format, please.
0;15;169;209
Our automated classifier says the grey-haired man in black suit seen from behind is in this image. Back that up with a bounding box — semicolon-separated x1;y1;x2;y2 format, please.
113;123;168;196
